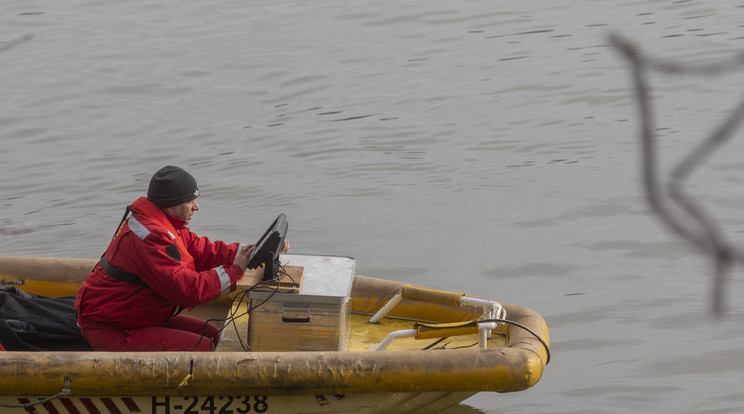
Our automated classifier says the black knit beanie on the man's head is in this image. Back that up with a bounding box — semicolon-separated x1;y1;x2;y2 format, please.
147;165;199;208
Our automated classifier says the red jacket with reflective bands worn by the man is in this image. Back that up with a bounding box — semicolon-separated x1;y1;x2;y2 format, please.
75;197;243;329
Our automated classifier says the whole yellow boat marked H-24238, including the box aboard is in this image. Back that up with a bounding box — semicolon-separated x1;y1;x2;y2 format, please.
0;254;550;414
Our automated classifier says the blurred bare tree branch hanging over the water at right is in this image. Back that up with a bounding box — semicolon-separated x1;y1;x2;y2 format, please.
610;34;744;315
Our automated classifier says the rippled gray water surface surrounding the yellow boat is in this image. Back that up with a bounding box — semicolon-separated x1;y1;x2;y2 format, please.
0;0;744;413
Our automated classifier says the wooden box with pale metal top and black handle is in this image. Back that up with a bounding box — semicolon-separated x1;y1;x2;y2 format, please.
248;254;355;352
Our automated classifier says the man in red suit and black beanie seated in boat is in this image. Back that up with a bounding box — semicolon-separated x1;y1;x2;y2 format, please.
75;166;289;351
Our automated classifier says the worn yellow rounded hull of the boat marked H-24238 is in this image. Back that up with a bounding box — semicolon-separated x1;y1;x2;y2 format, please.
0;257;549;414
